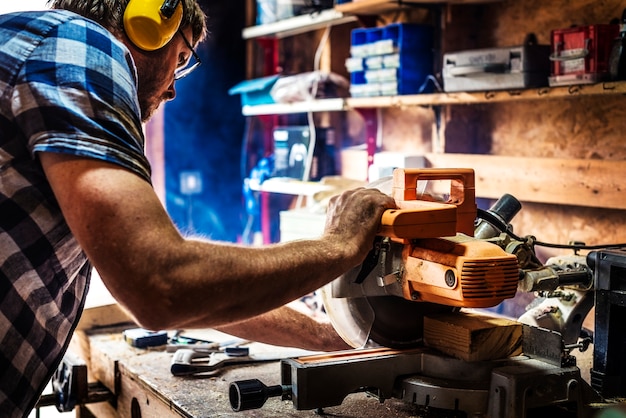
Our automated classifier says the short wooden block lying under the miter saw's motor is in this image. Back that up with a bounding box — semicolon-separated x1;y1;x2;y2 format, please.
424;312;522;361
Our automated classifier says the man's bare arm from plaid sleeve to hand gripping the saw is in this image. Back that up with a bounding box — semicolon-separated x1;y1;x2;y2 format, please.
40;153;394;346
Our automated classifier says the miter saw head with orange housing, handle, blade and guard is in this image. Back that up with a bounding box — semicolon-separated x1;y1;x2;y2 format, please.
322;168;519;348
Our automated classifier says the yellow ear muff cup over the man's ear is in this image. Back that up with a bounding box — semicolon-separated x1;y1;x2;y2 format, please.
124;0;183;51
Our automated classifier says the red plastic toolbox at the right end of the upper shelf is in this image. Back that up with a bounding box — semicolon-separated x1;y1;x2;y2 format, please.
549;24;619;86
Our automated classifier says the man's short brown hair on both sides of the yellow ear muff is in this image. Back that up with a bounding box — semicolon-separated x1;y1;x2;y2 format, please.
48;0;207;43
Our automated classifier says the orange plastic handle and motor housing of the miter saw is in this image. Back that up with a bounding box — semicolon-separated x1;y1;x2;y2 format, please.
380;169;519;308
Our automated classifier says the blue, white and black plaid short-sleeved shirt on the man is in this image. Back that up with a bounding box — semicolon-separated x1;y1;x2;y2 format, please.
0;10;150;417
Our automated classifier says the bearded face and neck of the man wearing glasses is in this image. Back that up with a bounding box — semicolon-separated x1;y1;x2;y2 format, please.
131;28;197;122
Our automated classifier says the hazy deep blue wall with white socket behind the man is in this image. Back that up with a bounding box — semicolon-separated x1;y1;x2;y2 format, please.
163;0;245;242
